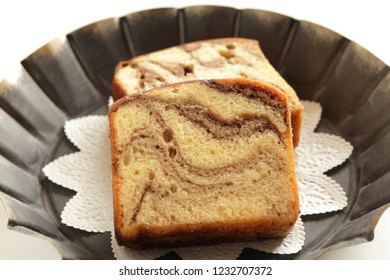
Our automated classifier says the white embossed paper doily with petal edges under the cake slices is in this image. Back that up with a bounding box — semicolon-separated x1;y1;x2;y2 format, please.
43;101;352;259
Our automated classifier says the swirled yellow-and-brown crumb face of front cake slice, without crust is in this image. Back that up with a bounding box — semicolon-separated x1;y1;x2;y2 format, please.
111;78;292;230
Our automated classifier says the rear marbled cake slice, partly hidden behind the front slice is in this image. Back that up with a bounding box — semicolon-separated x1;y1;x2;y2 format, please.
112;38;303;146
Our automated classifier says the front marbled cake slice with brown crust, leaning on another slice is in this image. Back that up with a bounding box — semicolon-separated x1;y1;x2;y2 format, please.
109;79;299;248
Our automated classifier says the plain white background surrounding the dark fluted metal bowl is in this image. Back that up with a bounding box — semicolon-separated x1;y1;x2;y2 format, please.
0;0;390;260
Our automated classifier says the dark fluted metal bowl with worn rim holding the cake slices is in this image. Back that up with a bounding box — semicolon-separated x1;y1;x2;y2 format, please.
0;6;390;259
